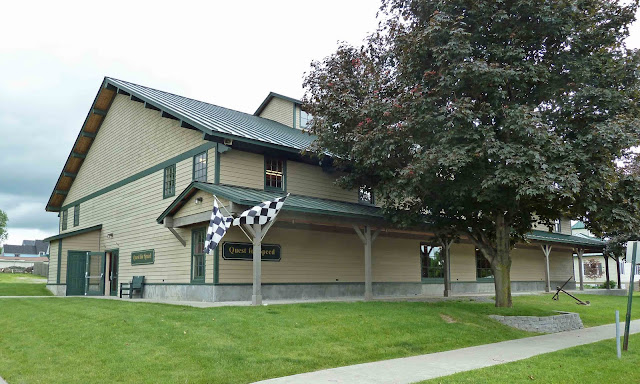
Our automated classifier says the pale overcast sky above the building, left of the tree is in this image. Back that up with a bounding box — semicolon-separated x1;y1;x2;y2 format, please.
0;0;640;244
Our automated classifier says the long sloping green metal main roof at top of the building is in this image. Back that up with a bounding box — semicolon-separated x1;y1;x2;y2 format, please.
105;77;316;152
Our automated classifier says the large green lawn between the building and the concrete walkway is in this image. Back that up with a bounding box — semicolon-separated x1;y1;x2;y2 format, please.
0;295;640;383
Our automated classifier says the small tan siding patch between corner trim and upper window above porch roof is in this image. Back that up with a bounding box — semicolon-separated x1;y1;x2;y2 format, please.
220;150;264;189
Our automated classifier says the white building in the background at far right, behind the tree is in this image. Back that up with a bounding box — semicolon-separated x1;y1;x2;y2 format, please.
571;221;640;288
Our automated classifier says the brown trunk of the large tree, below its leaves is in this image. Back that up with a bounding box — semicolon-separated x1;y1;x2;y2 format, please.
491;215;513;307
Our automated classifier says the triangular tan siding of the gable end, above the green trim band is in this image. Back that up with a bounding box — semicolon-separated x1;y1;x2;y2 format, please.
64;95;204;210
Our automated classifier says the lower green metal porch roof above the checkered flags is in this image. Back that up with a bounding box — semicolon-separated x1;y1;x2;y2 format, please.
157;181;383;223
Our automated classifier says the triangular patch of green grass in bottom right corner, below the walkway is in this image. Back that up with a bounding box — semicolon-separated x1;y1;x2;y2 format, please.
421;334;640;384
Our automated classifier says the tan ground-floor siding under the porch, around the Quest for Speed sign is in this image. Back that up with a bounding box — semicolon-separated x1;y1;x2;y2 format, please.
218;224;420;283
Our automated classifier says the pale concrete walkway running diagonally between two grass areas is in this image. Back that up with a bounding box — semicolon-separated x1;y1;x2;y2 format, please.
254;320;640;384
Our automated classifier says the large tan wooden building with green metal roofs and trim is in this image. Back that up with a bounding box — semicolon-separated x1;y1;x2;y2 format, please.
46;78;602;301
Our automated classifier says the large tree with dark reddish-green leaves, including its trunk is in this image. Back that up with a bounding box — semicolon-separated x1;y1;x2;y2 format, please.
304;0;640;306
